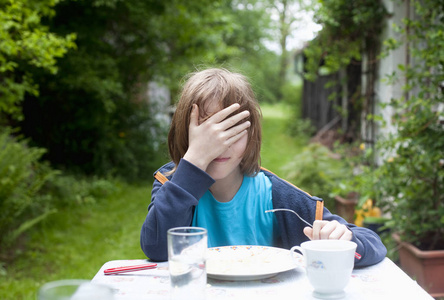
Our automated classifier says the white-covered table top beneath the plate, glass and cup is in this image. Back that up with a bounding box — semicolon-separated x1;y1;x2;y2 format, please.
92;258;433;300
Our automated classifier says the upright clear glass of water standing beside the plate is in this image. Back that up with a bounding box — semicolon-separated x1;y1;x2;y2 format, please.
168;227;208;300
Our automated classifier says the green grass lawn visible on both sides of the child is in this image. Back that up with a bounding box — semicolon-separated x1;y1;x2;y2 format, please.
0;105;306;300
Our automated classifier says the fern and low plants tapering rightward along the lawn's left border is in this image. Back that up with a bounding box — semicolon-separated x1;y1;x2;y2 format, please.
0;128;119;255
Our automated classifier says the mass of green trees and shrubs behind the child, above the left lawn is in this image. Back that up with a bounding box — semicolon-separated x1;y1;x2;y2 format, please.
0;0;279;255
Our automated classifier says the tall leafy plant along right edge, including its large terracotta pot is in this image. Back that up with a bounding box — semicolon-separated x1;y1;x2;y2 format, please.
375;0;444;297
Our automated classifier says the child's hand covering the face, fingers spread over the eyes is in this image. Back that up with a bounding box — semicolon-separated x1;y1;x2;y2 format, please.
183;103;250;171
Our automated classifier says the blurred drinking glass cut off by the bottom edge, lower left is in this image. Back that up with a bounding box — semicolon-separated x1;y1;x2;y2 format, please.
37;279;113;300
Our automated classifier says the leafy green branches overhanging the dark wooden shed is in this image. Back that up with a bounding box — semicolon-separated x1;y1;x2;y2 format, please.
304;0;387;80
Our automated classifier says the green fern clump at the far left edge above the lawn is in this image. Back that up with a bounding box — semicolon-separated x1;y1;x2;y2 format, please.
0;129;57;247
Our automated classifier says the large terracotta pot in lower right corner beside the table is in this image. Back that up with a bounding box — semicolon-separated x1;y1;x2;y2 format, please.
393;234;444;298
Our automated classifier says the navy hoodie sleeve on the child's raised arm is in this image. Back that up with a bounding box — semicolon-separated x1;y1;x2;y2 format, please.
140;159;214;261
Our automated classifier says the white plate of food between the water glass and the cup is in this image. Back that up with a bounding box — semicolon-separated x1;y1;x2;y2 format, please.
207;246;302;280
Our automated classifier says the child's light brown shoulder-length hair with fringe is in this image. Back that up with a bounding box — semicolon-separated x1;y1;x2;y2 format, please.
168;68;262;176
